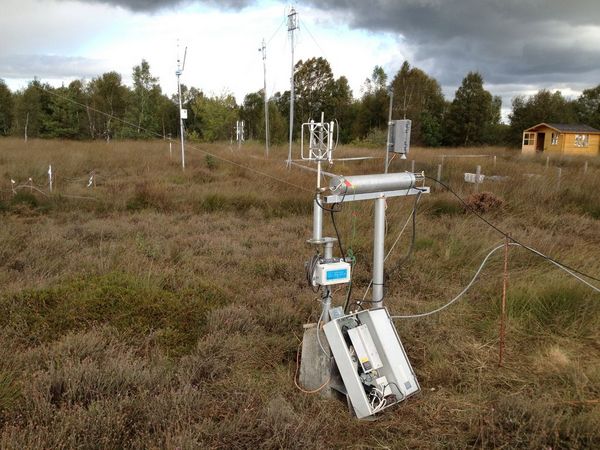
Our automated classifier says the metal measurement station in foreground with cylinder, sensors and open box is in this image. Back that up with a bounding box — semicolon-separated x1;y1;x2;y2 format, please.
289;114;429;418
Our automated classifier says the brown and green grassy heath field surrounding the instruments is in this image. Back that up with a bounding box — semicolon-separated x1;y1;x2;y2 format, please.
0;139;600;449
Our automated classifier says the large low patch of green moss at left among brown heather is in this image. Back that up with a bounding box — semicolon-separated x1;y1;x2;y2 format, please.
0;273;227;354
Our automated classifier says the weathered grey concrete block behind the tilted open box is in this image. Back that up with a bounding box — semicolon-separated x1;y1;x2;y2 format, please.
298;323;333;397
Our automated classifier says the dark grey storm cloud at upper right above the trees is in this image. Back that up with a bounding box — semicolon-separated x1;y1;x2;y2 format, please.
300;0;600;89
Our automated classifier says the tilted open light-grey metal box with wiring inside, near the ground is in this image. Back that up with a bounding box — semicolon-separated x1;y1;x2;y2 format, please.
323;308;420;419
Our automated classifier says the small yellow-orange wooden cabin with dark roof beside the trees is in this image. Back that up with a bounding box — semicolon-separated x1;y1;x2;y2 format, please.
521;123;600;156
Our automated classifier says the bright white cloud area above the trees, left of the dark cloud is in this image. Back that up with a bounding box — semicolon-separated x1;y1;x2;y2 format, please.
0;0;408;102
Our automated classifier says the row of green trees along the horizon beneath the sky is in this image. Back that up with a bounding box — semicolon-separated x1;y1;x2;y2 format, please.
0;57;600;147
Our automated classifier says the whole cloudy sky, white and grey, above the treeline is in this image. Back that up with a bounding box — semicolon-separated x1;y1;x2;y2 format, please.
0;0;600;120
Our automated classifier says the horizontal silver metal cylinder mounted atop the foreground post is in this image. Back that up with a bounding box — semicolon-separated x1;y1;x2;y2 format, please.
329;172;423;195
